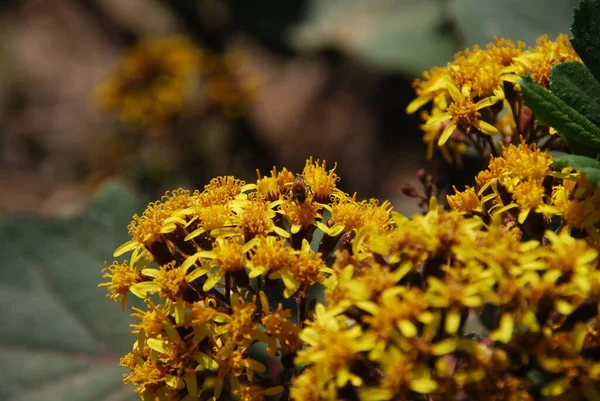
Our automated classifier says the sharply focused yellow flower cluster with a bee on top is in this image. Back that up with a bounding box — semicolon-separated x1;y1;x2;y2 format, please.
100;159;393;400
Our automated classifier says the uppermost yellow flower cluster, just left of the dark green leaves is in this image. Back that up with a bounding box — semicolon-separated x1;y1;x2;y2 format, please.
407;34;581;164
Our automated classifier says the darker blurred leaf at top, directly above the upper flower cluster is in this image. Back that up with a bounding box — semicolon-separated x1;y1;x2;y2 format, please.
454;0;578;46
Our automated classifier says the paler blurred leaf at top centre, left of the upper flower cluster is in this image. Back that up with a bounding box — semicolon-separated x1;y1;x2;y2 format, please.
291;0;457;75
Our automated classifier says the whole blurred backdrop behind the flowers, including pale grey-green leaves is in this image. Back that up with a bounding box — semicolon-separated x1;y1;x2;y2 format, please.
0;0;577;401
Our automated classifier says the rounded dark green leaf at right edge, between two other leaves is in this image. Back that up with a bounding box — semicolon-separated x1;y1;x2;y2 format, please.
550;62;600;127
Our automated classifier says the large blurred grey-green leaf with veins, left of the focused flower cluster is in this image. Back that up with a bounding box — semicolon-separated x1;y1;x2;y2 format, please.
0;180;141;401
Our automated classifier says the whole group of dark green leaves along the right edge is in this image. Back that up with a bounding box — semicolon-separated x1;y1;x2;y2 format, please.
521;0;600;181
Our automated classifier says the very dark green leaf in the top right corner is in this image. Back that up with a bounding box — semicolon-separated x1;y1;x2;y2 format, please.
571;0;600;80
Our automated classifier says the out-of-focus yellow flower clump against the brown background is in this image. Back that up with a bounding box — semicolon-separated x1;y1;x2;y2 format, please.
95;35;261;128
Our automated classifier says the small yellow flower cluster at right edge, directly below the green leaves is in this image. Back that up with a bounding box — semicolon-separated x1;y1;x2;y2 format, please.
447;142;600;243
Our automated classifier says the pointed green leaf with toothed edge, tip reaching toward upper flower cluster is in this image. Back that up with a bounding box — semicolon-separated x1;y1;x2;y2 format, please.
519;77;600;156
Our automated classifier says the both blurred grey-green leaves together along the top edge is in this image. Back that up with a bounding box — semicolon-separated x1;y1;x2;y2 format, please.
290;0;577;76
